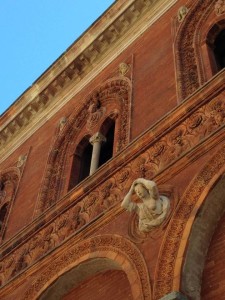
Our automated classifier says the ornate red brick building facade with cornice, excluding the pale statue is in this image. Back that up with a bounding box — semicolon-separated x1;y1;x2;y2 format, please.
0;0;225;300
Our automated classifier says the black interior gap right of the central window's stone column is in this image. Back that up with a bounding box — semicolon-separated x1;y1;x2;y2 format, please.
99;120;115;167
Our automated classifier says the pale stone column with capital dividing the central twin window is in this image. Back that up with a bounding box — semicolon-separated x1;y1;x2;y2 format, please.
89;132;106;175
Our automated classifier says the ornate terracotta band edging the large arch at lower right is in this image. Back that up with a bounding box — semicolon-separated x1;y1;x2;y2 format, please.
153;146;225;299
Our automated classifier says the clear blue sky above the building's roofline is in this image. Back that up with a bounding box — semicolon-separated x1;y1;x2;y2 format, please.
0;0;114;114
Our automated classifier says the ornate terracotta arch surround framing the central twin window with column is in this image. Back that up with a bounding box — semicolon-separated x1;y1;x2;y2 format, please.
34;77;132;217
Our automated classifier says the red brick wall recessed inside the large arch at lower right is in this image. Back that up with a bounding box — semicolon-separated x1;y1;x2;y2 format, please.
202;215;225;300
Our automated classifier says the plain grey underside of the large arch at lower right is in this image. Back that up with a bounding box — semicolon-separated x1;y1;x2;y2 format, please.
181;170;225;300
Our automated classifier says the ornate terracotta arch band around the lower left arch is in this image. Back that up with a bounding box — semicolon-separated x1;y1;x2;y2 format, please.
23;235;152;300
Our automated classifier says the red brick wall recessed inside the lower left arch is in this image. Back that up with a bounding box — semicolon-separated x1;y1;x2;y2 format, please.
63;270;133;300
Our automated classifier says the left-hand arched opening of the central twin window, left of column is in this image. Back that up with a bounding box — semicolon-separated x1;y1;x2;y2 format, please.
69;136;92;190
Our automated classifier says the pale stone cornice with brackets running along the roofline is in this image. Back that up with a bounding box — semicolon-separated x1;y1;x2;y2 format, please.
0;0;177;162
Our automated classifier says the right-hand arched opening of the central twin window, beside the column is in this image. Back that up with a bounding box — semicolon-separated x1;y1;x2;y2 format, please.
99;118;115;167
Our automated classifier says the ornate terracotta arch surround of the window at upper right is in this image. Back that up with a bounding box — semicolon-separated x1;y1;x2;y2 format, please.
174;0;215;100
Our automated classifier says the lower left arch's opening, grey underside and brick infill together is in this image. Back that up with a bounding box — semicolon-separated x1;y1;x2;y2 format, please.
39;258;133;300
